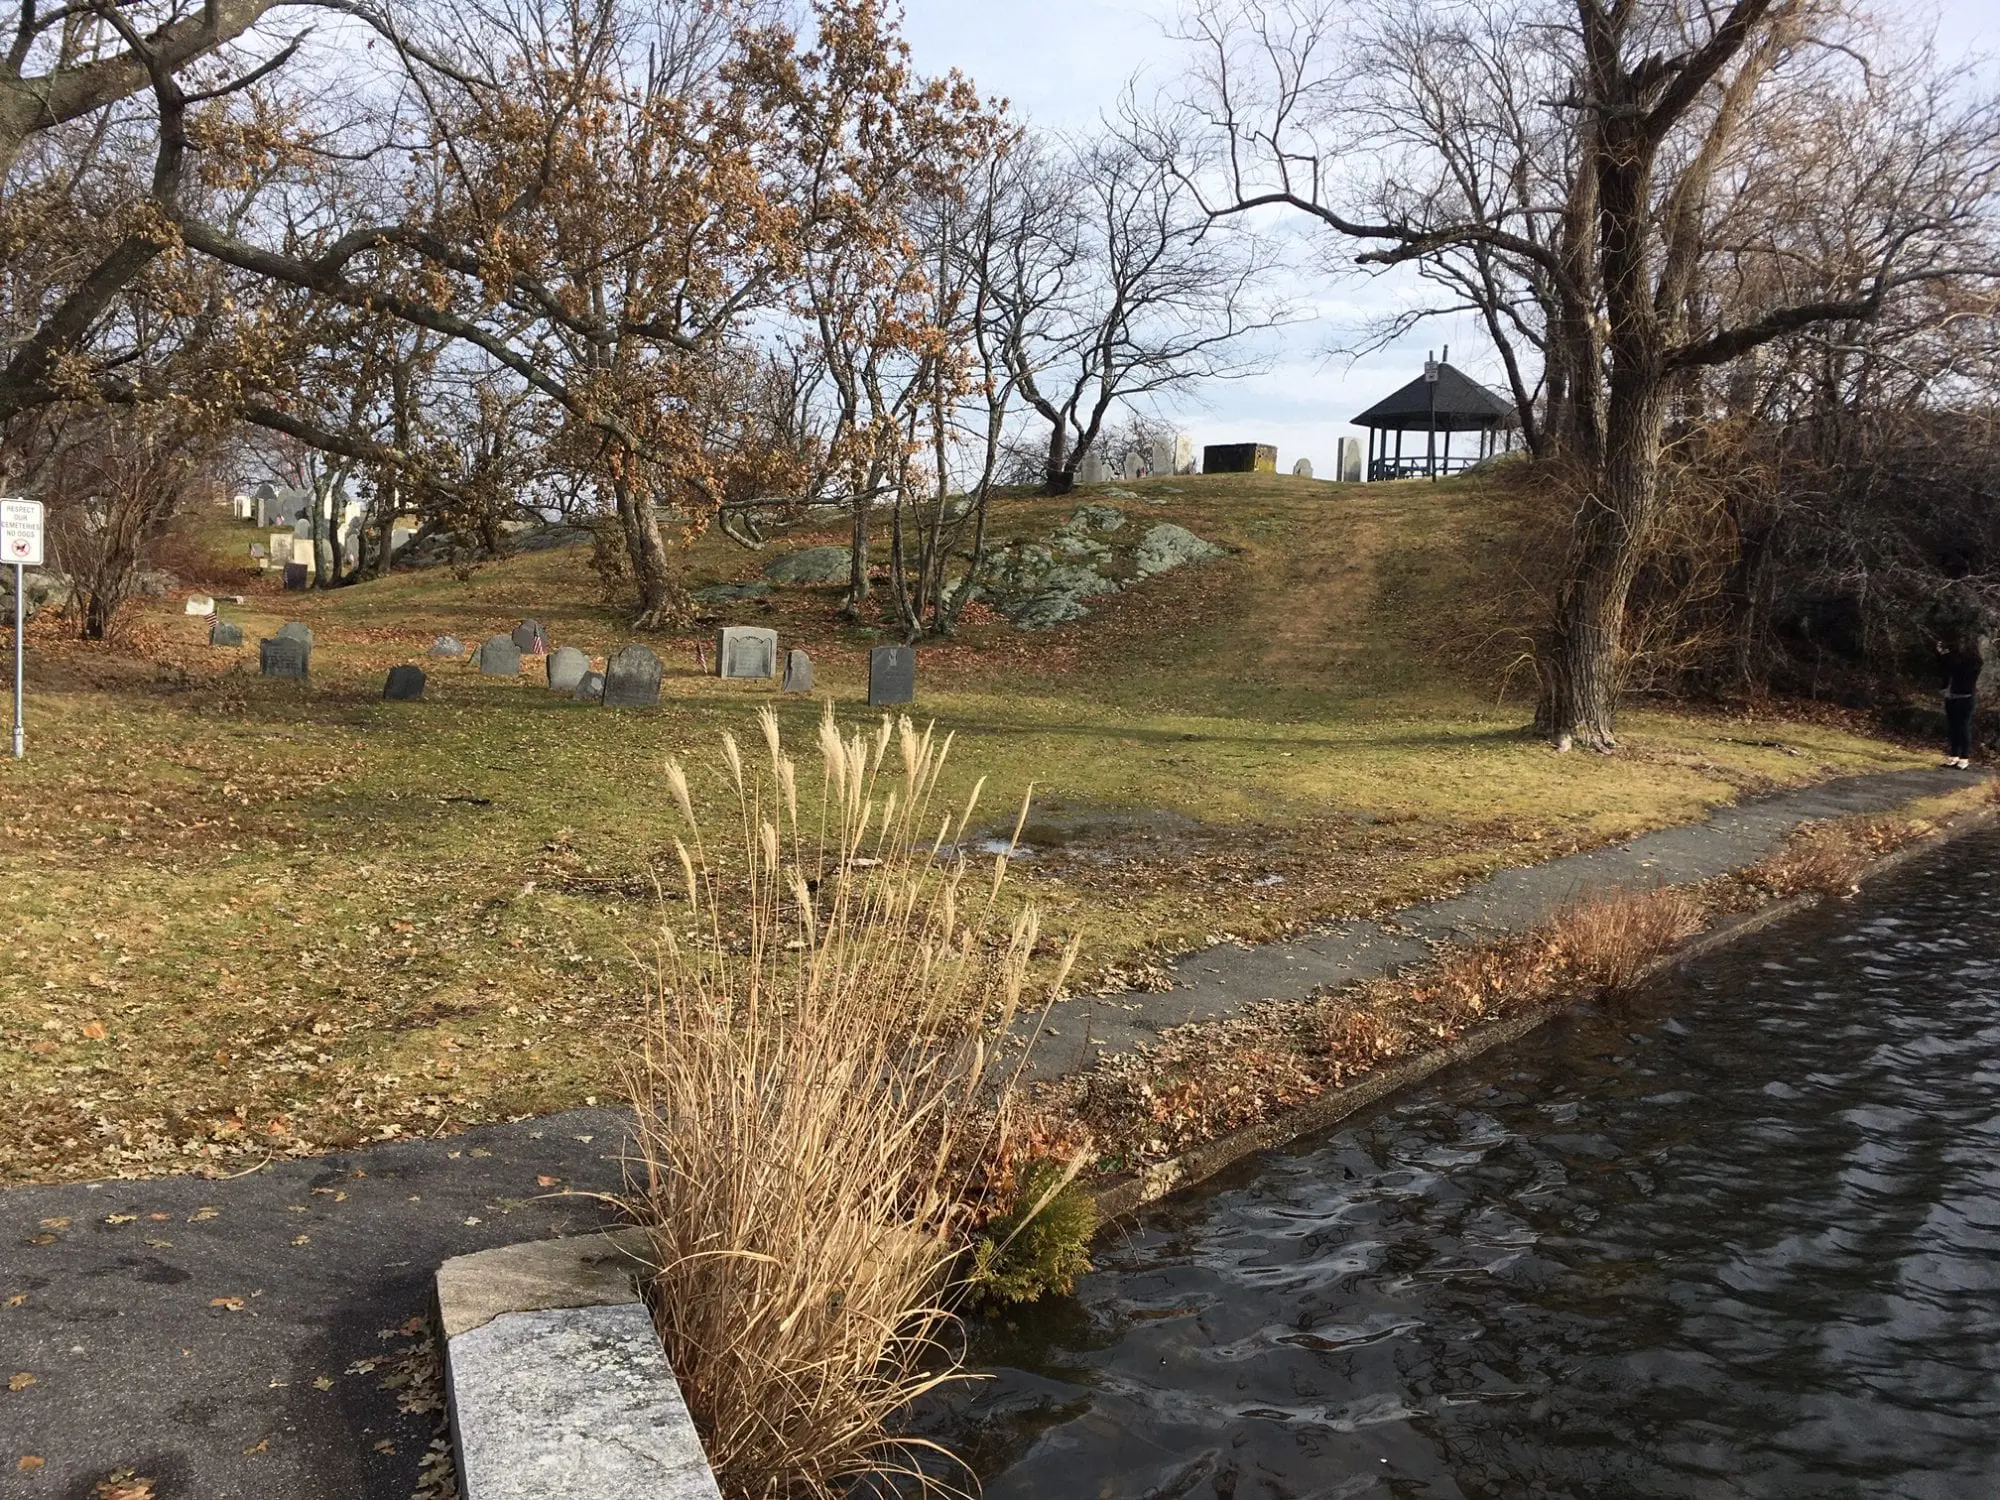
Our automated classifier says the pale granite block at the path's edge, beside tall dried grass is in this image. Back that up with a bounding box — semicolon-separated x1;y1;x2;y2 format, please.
436;1230;722;1500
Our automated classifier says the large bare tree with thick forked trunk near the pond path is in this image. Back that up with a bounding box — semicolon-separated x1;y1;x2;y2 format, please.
1148;0;2000;750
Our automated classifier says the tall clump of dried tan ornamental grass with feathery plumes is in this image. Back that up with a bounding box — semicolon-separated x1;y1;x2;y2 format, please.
628;710;1082;1500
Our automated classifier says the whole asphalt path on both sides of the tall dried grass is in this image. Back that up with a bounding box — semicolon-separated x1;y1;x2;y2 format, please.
0;772;1976;1500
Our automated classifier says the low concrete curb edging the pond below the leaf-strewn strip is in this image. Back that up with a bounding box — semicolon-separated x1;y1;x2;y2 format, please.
1092;808;2000;1226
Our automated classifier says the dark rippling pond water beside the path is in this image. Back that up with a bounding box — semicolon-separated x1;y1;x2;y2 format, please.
944;836;2000;1500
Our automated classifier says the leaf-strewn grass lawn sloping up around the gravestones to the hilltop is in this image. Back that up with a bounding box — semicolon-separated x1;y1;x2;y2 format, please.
0;476;1928;1182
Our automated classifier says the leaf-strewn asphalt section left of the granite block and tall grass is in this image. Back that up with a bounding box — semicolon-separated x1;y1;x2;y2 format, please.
0;1110;626;1500
